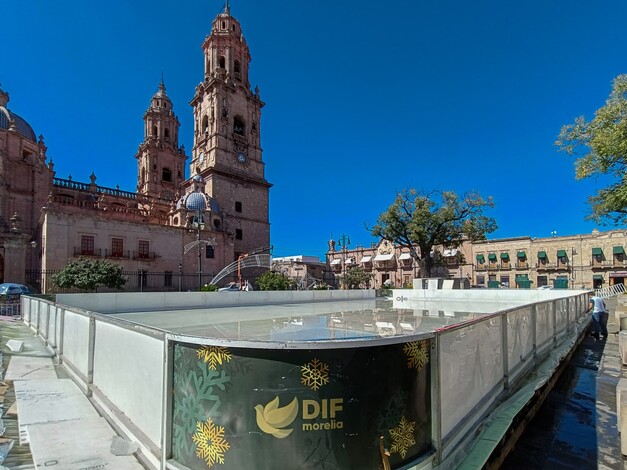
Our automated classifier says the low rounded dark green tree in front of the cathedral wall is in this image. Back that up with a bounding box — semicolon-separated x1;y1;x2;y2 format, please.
51;258;128;291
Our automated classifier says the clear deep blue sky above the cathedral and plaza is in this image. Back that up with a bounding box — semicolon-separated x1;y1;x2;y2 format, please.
0;0;627;256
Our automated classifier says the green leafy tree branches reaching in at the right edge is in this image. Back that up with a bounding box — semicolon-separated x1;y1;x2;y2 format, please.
555;75;627;225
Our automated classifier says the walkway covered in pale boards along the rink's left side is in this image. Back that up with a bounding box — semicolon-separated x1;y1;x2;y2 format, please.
0;317;144;470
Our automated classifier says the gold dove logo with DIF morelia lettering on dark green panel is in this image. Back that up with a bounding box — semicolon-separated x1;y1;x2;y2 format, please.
255;396;344;439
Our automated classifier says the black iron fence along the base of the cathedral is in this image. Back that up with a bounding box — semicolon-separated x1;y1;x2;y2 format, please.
26;270;237;293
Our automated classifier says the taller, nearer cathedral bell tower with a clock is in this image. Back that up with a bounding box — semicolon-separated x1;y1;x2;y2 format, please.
190;2;271;257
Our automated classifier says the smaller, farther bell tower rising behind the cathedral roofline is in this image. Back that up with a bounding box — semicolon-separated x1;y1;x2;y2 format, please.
135;80;187;201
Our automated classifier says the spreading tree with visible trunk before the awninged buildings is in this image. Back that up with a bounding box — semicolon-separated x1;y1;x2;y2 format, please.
370;189;497;277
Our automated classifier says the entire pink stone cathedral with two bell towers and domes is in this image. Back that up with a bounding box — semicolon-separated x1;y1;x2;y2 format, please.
0;2;271;293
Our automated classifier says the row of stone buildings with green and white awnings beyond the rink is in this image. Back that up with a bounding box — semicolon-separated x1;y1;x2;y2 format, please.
326;230;627;289
